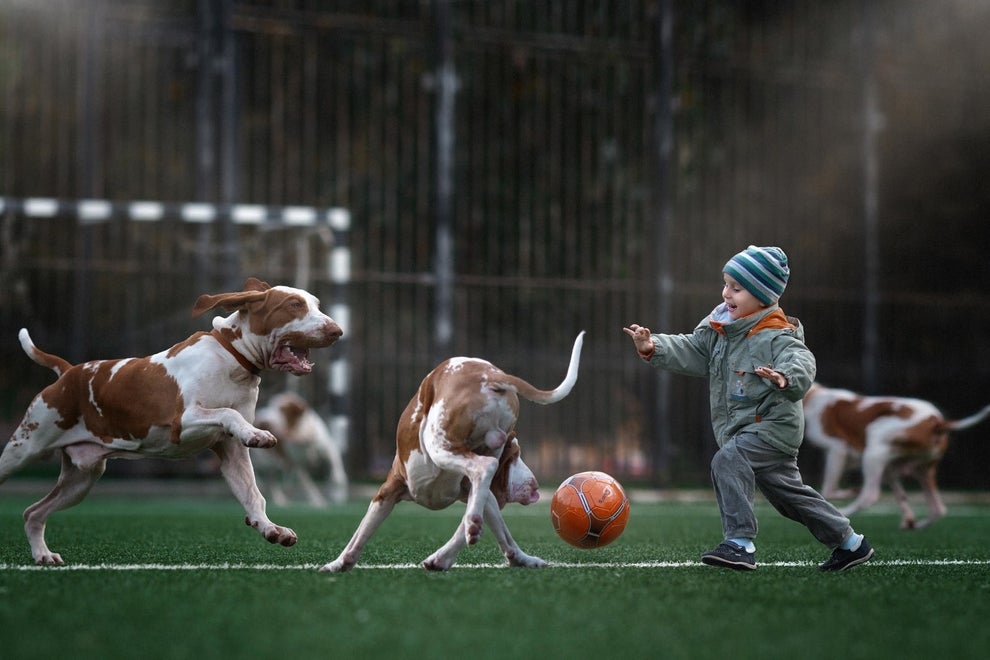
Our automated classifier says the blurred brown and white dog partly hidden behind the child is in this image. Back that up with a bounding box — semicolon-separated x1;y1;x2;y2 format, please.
804;383;990;529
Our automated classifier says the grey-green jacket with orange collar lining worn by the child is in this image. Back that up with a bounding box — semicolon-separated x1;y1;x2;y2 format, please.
649;304;816;456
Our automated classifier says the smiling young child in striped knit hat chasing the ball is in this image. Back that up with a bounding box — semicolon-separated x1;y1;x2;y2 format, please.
623;245;873;571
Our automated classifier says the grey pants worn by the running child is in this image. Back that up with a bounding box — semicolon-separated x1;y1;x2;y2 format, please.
712;433;853;548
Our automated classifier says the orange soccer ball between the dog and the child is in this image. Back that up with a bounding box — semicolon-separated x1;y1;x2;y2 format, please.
550;472;629;548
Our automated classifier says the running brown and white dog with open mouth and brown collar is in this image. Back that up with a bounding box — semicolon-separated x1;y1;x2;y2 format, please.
0;278;342;564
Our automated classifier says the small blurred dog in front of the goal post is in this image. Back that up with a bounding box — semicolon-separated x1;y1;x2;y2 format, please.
251;392;347;507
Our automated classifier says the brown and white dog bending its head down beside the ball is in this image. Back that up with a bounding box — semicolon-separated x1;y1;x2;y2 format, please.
320;332;584;573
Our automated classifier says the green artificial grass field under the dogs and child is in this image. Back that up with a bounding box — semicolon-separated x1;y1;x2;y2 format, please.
0;485;990;660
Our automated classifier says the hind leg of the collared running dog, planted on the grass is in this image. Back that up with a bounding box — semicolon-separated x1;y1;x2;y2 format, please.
24;444;107;565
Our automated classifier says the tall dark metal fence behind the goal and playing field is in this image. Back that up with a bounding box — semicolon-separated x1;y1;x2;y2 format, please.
0;0;990;486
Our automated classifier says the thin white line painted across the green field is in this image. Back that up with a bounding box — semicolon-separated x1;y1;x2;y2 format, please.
0;559;990;572
